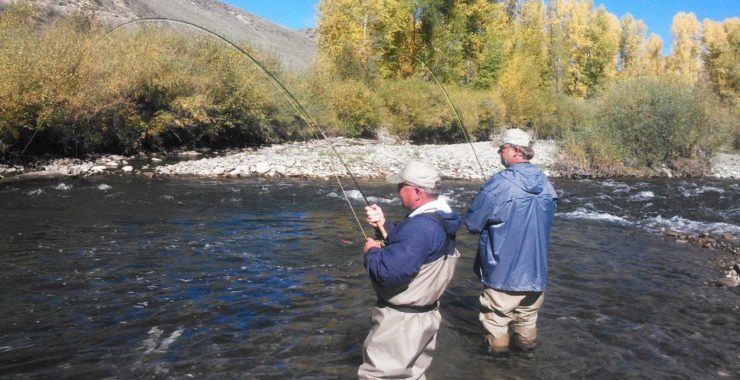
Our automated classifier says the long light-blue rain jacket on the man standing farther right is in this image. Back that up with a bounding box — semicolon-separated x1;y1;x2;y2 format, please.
465;162;557;292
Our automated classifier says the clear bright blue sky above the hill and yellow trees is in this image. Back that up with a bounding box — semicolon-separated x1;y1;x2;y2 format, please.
224;0;740;54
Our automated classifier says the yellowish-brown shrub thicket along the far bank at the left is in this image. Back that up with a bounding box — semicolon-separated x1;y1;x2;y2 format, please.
0;2;300;158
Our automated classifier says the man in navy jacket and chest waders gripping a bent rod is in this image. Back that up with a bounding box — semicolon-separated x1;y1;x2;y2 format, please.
358;161;462;379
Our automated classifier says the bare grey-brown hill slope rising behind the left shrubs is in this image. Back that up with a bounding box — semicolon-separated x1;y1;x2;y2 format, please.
0;0;316;71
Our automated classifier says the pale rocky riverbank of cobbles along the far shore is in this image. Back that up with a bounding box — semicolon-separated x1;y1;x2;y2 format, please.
0;138;740;180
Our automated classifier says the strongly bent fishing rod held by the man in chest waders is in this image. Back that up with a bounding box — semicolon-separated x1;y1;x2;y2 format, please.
101;17;376;239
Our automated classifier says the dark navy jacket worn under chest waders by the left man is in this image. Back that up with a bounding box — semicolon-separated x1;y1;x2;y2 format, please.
365;210;462;290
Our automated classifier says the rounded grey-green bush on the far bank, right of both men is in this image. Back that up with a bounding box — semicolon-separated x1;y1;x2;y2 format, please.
559;78;738;175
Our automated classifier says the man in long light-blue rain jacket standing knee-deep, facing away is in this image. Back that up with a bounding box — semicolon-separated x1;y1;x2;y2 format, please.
465;129;557;354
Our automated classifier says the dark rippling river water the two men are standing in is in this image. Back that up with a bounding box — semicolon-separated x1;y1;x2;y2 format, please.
0;177;740;379
